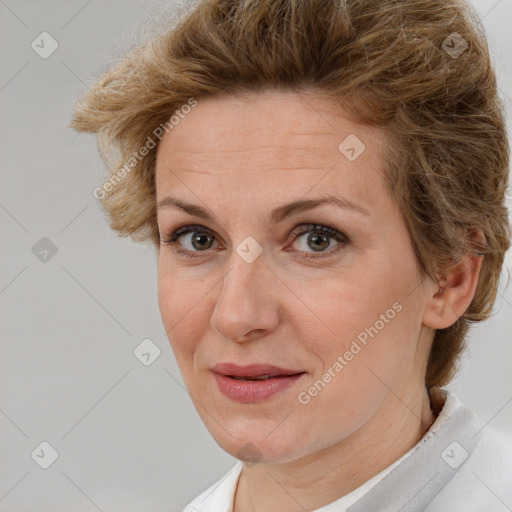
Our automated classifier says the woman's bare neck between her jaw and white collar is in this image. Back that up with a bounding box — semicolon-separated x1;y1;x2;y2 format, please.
233;388;435;512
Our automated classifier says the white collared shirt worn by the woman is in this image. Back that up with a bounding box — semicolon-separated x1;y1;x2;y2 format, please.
183;390;512;512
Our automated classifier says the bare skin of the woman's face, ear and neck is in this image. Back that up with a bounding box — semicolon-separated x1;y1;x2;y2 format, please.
156;90;481;512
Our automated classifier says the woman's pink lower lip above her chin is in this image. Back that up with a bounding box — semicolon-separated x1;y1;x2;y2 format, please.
214;373;304;403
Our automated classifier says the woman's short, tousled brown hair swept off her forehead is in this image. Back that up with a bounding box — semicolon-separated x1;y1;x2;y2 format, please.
71;0;511;388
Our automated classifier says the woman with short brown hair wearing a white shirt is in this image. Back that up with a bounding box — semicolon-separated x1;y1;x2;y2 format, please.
73;0;512;512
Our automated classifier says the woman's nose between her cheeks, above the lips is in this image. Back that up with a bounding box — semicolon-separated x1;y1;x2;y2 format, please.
210;251;280;343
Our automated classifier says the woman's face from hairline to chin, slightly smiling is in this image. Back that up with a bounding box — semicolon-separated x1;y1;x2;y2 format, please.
156;91;437;462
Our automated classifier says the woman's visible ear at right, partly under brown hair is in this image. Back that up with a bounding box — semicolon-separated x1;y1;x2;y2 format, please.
423;230;485;329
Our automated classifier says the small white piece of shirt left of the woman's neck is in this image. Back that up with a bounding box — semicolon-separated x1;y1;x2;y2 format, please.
183;461;243;512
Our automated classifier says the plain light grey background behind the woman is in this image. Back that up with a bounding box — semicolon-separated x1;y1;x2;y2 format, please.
0;0;512;512
